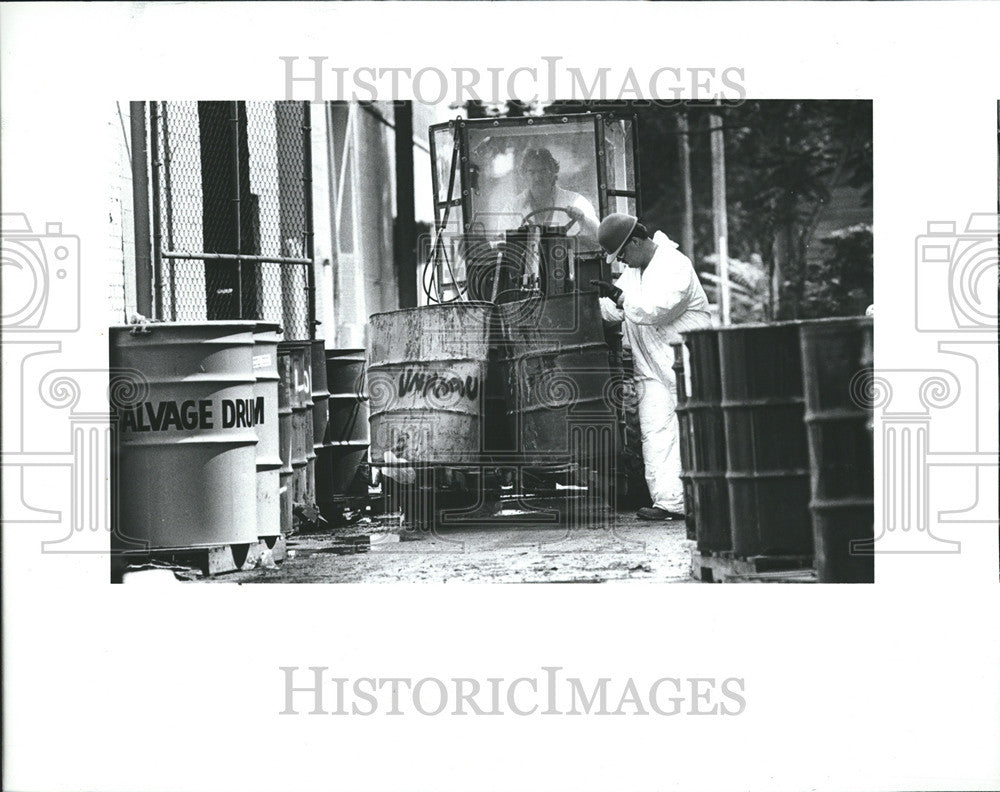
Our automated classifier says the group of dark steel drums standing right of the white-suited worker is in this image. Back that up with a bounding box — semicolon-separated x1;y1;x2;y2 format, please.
675;318;874;582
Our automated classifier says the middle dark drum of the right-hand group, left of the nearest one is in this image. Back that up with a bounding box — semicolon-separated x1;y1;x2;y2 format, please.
718;322;813;558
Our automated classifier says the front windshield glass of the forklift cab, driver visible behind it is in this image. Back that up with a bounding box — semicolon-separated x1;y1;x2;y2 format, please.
468;119;599;244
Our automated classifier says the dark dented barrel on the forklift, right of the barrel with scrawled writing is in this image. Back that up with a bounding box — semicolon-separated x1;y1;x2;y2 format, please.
498;291;617;470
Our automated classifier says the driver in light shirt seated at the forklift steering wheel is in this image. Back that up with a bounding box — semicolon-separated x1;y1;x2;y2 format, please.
507;148;598;250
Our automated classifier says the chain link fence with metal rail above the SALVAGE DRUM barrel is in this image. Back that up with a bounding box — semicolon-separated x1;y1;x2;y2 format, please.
150;101;315;340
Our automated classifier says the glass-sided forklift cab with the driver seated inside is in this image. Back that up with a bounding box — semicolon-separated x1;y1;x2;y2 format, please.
430;113;640;303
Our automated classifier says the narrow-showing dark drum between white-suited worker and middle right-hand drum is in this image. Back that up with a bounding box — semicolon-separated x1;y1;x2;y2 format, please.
677;328;733;553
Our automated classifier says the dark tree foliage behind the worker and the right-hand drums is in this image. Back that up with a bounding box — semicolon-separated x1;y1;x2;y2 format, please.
639;100;872;319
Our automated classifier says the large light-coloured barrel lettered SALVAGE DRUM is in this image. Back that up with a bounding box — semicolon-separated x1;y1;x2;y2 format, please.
109;322;257;550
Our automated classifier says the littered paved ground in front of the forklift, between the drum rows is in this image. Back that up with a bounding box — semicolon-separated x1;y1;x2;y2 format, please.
206;504;692;583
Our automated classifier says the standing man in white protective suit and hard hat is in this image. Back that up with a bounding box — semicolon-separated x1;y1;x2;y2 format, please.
591;214;711;520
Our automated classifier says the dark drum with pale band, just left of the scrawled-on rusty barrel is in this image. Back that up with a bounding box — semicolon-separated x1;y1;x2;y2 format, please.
316;349;369;508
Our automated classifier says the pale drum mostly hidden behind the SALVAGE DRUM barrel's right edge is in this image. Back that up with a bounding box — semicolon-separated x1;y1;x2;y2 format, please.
253;322;282;538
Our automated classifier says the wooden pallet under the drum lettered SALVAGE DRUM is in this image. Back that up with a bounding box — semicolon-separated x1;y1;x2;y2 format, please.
111;536;288;583
